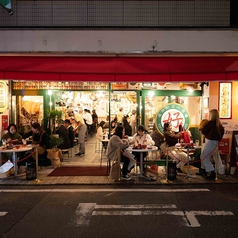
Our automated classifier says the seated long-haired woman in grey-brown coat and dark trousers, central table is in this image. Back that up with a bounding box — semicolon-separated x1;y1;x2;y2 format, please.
106;125;131;180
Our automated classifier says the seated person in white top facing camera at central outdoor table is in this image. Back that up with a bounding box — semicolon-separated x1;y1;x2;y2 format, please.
131;125;155;170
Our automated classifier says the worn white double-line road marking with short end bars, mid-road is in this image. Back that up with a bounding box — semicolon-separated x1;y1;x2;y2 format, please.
74;203;234;227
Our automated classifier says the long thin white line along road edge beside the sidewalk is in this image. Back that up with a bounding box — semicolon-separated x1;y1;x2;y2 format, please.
0;188;210;193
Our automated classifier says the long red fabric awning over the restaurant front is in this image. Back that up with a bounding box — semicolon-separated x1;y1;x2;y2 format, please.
0;54;238;82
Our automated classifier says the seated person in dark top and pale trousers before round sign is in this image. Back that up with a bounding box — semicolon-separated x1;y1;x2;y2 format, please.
164;122;187;173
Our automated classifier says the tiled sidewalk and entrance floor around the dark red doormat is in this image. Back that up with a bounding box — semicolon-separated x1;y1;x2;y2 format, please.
0;138;238;186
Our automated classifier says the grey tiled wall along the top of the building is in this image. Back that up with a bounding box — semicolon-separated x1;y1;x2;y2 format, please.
0;0;230;28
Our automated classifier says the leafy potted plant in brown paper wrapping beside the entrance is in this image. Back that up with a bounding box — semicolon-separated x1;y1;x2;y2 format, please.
47;135;63;169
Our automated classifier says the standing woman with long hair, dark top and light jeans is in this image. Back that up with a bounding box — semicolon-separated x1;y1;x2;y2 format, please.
201;109;224;180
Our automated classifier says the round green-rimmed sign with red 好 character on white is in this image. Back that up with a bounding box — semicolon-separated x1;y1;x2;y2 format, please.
155;103;190;134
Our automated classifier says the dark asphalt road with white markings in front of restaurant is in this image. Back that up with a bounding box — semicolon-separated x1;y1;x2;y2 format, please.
0;184;238;238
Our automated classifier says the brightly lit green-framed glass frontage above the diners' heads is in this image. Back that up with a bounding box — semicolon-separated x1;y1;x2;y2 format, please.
11;81;203;137
